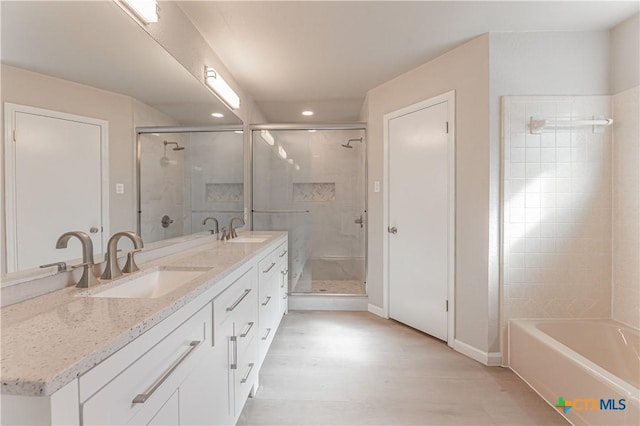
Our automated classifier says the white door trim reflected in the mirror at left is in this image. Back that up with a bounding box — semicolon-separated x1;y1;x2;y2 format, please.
4;102;110;272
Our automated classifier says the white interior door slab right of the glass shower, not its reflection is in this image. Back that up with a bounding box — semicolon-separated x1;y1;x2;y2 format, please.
387;95;453;341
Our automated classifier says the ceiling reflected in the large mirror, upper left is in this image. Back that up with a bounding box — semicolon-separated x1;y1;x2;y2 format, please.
1;1;241;126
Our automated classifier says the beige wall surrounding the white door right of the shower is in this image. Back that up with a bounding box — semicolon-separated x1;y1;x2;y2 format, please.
366;35;489;351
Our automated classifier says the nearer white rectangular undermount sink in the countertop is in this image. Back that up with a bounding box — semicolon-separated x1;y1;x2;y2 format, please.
88;269;206;299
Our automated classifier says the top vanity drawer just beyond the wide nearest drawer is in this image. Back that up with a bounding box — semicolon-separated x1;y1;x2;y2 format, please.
213;268;257;324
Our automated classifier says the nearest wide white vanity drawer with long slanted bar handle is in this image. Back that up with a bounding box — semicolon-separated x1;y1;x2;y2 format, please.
81;303;212;425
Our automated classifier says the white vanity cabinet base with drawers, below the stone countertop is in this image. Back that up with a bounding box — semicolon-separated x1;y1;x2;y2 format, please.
1;233;287;425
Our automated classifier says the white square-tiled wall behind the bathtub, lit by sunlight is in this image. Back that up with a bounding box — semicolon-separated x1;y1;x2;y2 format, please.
501;96;612;354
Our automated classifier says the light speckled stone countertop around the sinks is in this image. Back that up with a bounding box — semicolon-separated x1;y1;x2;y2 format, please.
0;231;286;396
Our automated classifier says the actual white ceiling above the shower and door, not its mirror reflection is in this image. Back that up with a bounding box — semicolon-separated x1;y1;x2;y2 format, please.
179;1;639;122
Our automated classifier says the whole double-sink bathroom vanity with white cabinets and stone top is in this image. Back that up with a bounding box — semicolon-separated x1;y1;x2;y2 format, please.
2;232;288;425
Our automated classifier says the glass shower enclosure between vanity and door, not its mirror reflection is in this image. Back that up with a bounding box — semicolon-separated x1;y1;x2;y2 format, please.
252;128;366;296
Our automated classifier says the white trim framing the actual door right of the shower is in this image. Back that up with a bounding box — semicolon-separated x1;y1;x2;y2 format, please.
381;90;456;346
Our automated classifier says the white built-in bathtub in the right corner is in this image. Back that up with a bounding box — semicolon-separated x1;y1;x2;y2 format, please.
509;320;640;425
